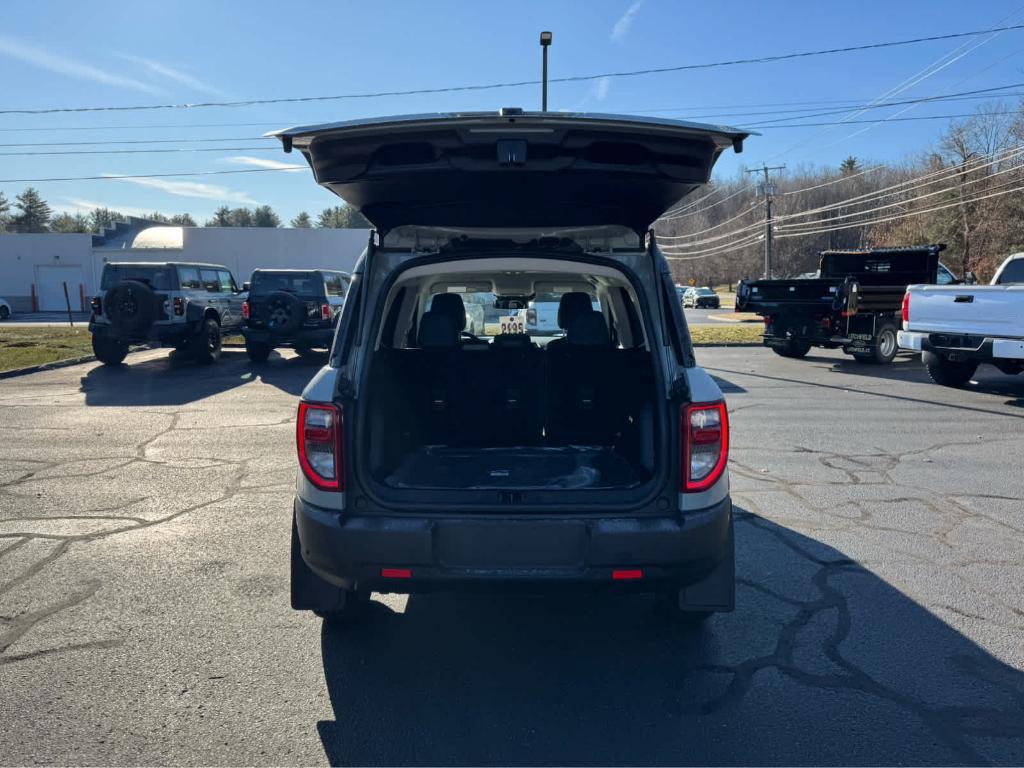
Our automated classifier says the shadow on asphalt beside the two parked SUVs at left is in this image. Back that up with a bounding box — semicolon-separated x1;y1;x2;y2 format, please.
79;348;326;407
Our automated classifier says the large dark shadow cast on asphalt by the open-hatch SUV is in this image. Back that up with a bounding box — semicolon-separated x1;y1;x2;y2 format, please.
317;512;1024;765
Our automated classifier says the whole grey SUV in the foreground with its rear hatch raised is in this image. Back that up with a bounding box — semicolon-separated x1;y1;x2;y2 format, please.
276;110;746;622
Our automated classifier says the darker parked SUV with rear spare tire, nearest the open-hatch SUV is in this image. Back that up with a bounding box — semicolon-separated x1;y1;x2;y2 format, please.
242;269;351;362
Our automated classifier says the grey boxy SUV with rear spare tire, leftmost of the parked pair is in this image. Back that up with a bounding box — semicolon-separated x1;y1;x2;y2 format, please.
89;261;246;366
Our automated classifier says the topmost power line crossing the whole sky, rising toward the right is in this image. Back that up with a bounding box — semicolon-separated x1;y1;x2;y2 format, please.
6;25;1024;115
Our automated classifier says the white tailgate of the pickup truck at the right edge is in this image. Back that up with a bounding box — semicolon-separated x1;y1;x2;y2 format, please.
906;286;1024;338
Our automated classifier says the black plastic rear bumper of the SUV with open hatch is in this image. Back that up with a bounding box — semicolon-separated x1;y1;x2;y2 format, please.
295;498;732;592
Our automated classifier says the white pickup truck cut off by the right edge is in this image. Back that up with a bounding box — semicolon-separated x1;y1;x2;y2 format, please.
897;253;1024;387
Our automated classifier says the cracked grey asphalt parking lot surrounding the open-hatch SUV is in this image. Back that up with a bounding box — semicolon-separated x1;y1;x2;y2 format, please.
0;347;1024;765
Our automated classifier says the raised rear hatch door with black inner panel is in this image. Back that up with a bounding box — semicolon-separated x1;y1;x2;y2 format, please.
270;111;749;233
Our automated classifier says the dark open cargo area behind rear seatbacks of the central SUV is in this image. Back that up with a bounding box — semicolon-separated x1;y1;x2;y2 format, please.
367;312;654;489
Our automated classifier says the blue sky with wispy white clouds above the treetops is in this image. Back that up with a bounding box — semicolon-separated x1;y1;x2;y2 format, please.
0;0;1024;222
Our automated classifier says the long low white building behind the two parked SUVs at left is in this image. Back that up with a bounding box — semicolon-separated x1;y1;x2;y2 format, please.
0;219;370;312
